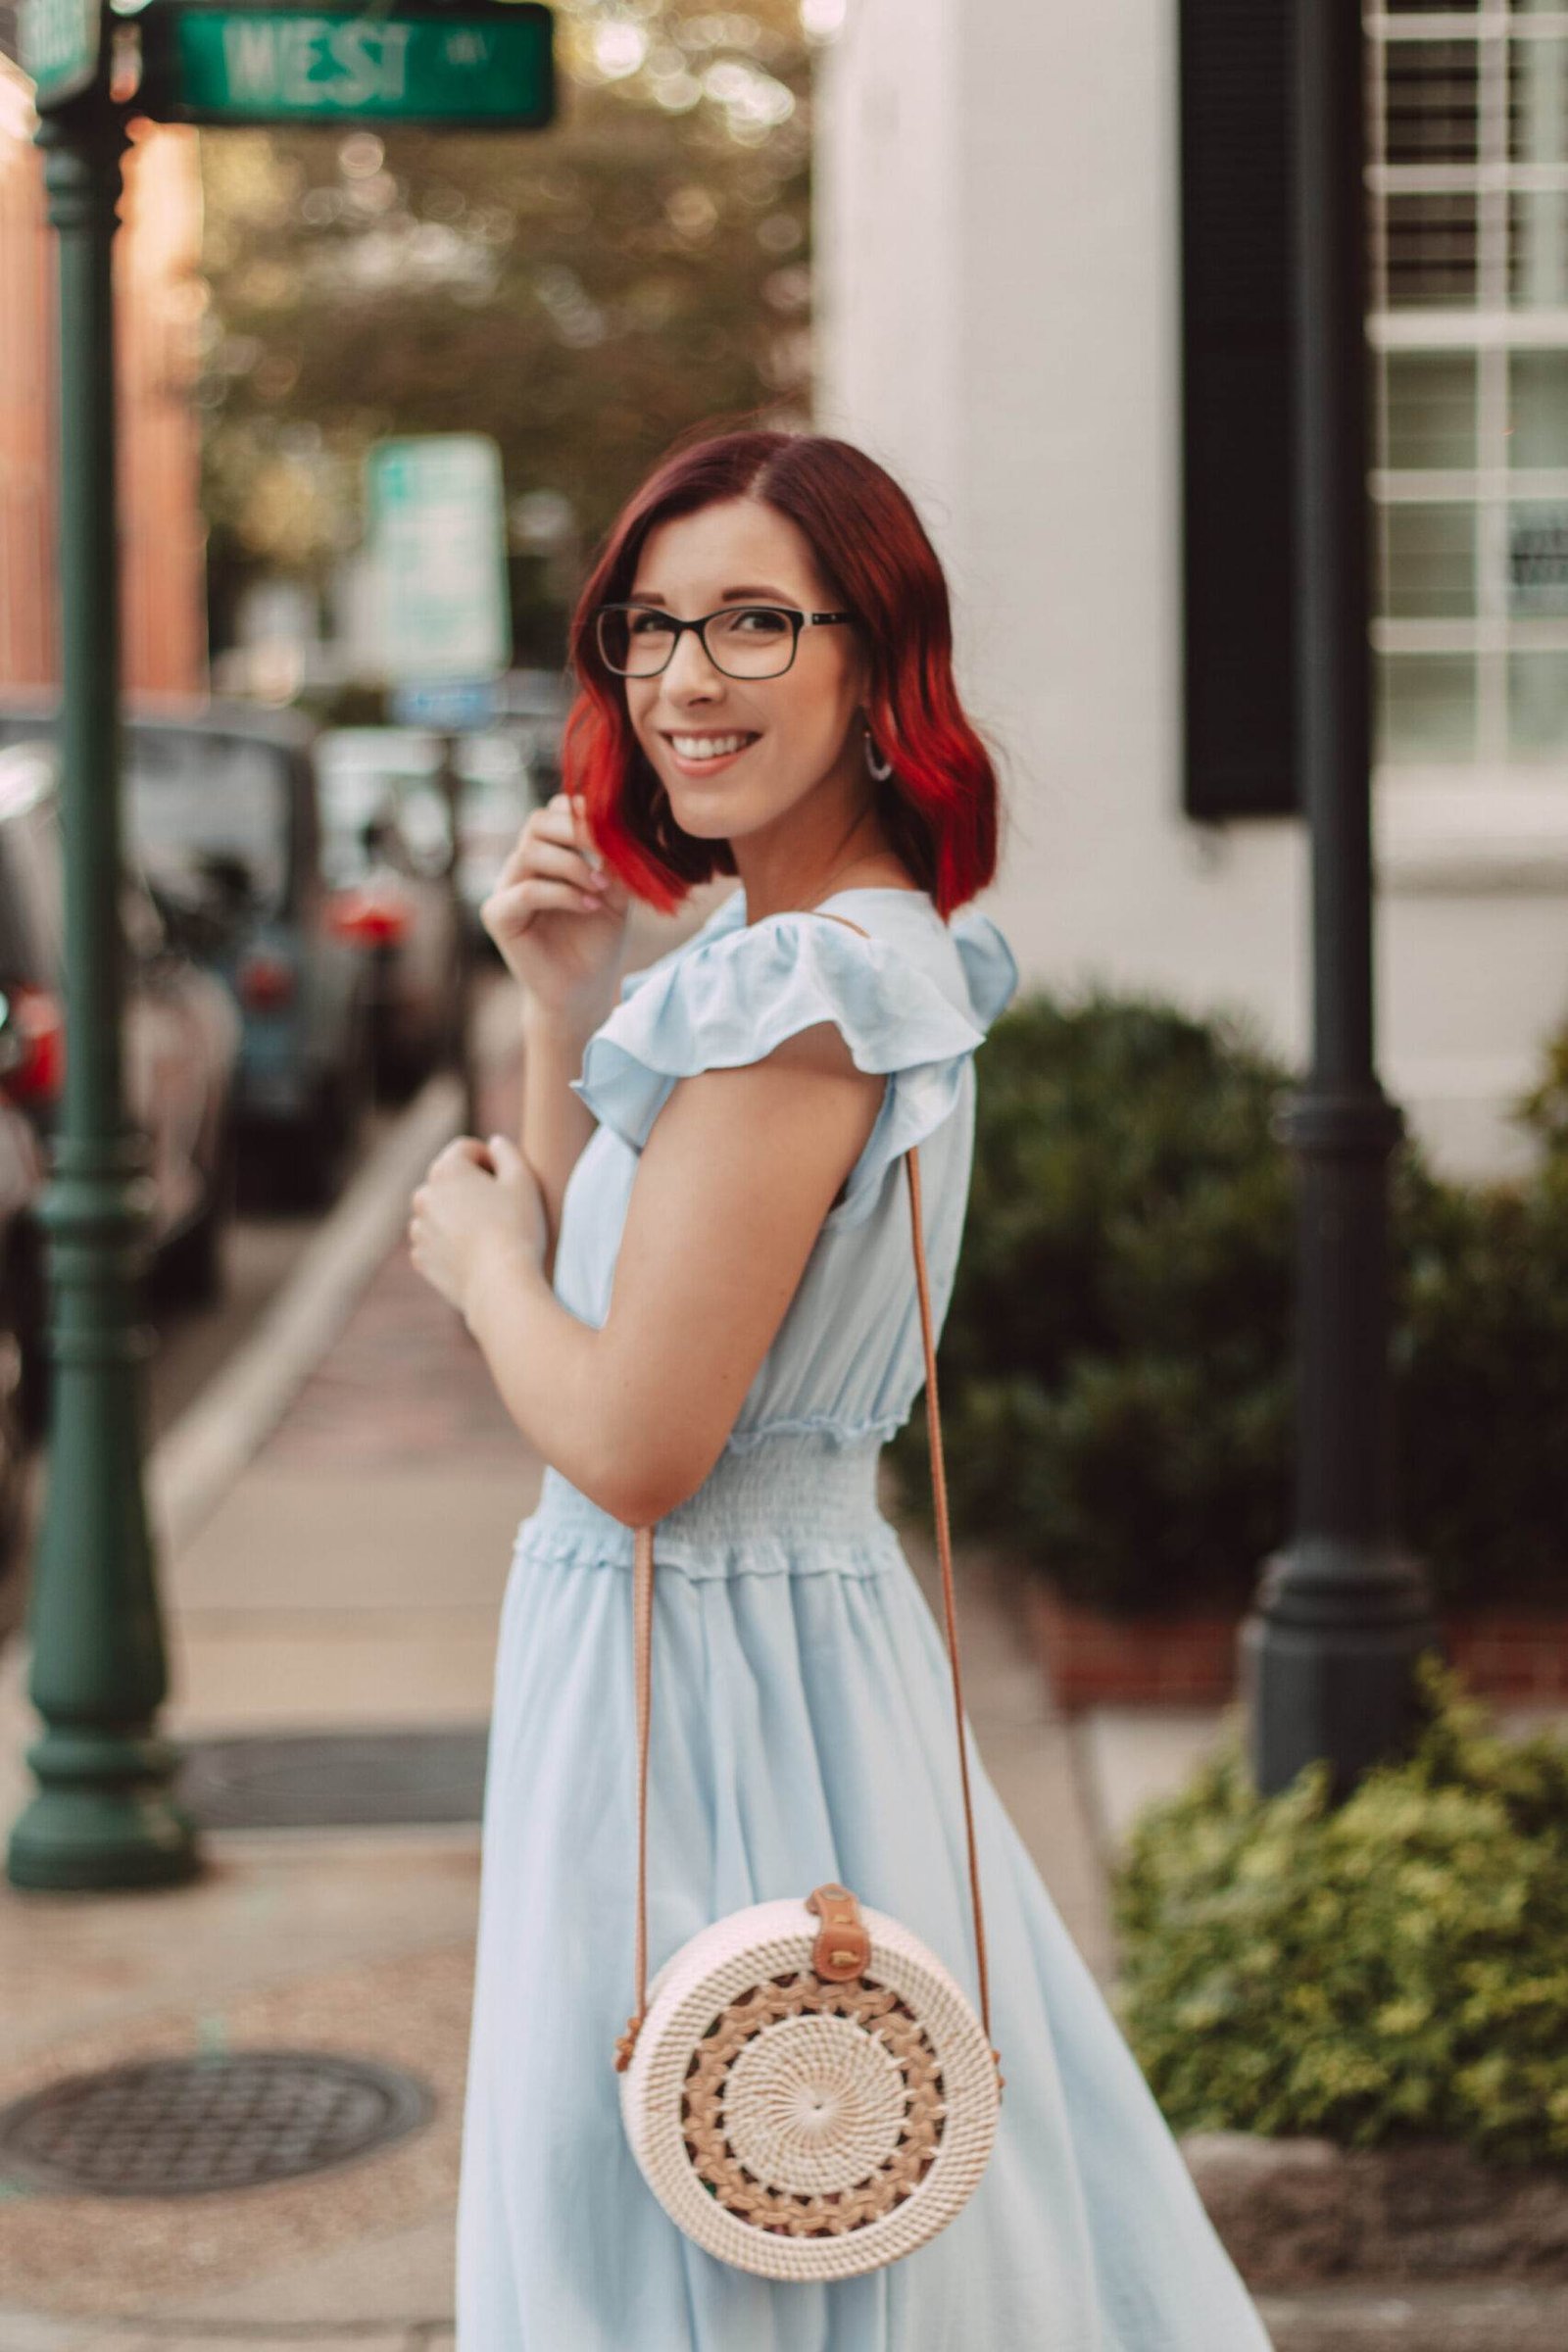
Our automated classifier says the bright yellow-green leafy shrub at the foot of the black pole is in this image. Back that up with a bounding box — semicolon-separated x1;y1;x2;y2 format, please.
1116;1660;1568;2162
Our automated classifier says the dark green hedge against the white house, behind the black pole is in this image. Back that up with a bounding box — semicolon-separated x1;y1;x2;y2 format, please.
891;993;1568;1613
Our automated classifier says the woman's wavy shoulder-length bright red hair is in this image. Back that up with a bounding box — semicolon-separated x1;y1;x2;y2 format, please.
564;430;997;919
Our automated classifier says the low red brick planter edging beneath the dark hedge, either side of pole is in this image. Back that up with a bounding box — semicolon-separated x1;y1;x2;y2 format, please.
1022;1578;1568;1715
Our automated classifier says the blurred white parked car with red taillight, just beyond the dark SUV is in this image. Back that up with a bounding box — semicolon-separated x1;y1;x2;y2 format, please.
315;727;467;1092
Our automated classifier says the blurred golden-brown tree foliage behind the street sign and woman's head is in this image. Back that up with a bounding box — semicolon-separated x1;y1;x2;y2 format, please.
202;0;811;654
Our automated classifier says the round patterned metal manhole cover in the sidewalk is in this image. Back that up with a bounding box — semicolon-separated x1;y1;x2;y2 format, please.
0;2051;435;2197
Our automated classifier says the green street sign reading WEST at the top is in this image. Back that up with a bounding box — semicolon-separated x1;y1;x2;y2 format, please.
139;0;555;131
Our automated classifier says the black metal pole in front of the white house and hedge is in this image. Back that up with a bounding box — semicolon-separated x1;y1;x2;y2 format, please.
1242;0;1439;1794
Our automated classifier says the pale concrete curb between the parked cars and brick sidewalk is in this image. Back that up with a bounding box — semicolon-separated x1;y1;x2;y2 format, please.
146;1070;464;1554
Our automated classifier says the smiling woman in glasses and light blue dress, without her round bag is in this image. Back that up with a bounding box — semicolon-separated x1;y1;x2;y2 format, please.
412;433;1267;2352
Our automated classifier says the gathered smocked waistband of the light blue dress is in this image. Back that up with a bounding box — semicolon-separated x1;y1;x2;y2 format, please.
517;1433;903;1576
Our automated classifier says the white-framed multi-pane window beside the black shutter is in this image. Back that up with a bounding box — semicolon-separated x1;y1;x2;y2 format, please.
1366;0;1568;776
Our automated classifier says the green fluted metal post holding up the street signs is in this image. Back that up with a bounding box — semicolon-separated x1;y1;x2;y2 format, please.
7;14;200;1891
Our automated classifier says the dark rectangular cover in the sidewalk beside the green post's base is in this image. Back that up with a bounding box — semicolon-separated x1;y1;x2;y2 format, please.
178;1724;487;1830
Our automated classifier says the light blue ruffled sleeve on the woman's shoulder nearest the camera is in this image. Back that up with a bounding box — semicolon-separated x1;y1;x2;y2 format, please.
571;912;992;1225
